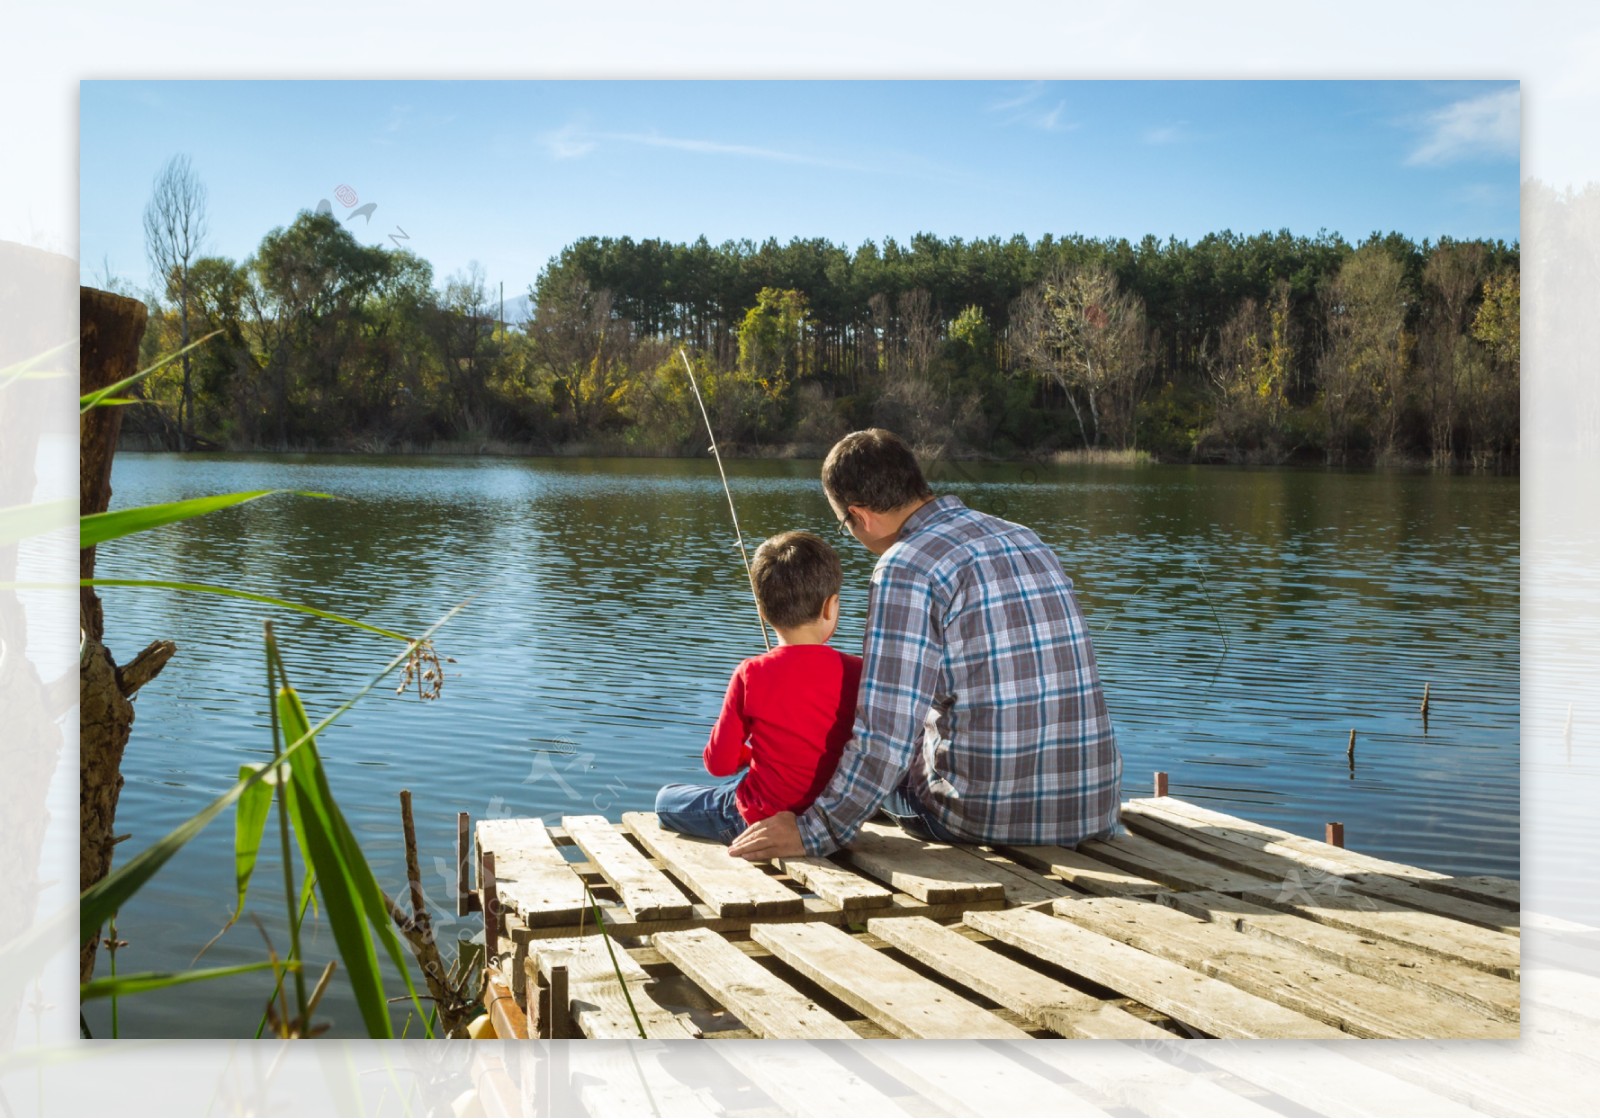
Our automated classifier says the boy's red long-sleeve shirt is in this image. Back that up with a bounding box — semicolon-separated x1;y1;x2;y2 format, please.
706;645;861;824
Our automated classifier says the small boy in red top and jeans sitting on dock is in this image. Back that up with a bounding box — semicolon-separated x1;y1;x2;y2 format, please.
656;531;861;844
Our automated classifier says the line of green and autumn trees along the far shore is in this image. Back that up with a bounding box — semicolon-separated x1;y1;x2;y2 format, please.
126;179;1520;469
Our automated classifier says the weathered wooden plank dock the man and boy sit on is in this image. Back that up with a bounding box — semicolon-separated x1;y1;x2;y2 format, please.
458;796;1520;1041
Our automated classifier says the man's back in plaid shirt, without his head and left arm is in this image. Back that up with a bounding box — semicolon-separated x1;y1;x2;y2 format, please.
902;498;1122;844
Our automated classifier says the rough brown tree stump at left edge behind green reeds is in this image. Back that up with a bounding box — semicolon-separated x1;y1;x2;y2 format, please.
78;288;176;981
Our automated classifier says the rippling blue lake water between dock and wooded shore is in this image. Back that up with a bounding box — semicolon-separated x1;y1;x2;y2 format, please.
86;453;1520;1037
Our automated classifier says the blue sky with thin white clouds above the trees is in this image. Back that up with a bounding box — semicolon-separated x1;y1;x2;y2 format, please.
78;80;1522;299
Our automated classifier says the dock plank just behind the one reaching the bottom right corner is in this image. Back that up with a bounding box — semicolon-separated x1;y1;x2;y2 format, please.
1157;893;1522;1021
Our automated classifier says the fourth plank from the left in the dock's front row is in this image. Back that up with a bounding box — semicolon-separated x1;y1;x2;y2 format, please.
867;917;1173;1041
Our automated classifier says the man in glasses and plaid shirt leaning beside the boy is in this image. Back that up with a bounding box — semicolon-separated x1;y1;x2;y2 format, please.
728;429;1122;860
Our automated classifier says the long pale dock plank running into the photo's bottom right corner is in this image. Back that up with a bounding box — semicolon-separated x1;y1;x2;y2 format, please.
1054;898;1517;1039
